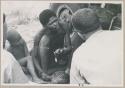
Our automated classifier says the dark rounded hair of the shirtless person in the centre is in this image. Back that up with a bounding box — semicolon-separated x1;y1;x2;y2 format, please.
39;9;56;25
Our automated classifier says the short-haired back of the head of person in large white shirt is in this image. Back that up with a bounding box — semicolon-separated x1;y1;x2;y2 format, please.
72;8;100;33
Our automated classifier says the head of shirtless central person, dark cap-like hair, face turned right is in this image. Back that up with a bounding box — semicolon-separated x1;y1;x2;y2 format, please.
39;9;66;33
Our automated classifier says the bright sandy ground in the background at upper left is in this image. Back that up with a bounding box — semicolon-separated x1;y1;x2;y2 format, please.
1;1;49;51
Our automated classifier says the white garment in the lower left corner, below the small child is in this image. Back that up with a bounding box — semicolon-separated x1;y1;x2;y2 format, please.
1;50;29;83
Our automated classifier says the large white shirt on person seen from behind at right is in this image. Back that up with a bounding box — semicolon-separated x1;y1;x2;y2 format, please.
70;30;123;86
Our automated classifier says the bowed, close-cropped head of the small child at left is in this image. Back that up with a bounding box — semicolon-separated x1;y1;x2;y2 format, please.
7;30;22;45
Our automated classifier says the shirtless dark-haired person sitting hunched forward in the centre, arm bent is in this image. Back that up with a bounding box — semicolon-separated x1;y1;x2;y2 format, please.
32;9;71;80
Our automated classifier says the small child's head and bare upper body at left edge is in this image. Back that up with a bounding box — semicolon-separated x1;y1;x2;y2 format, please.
7;30;28;60
